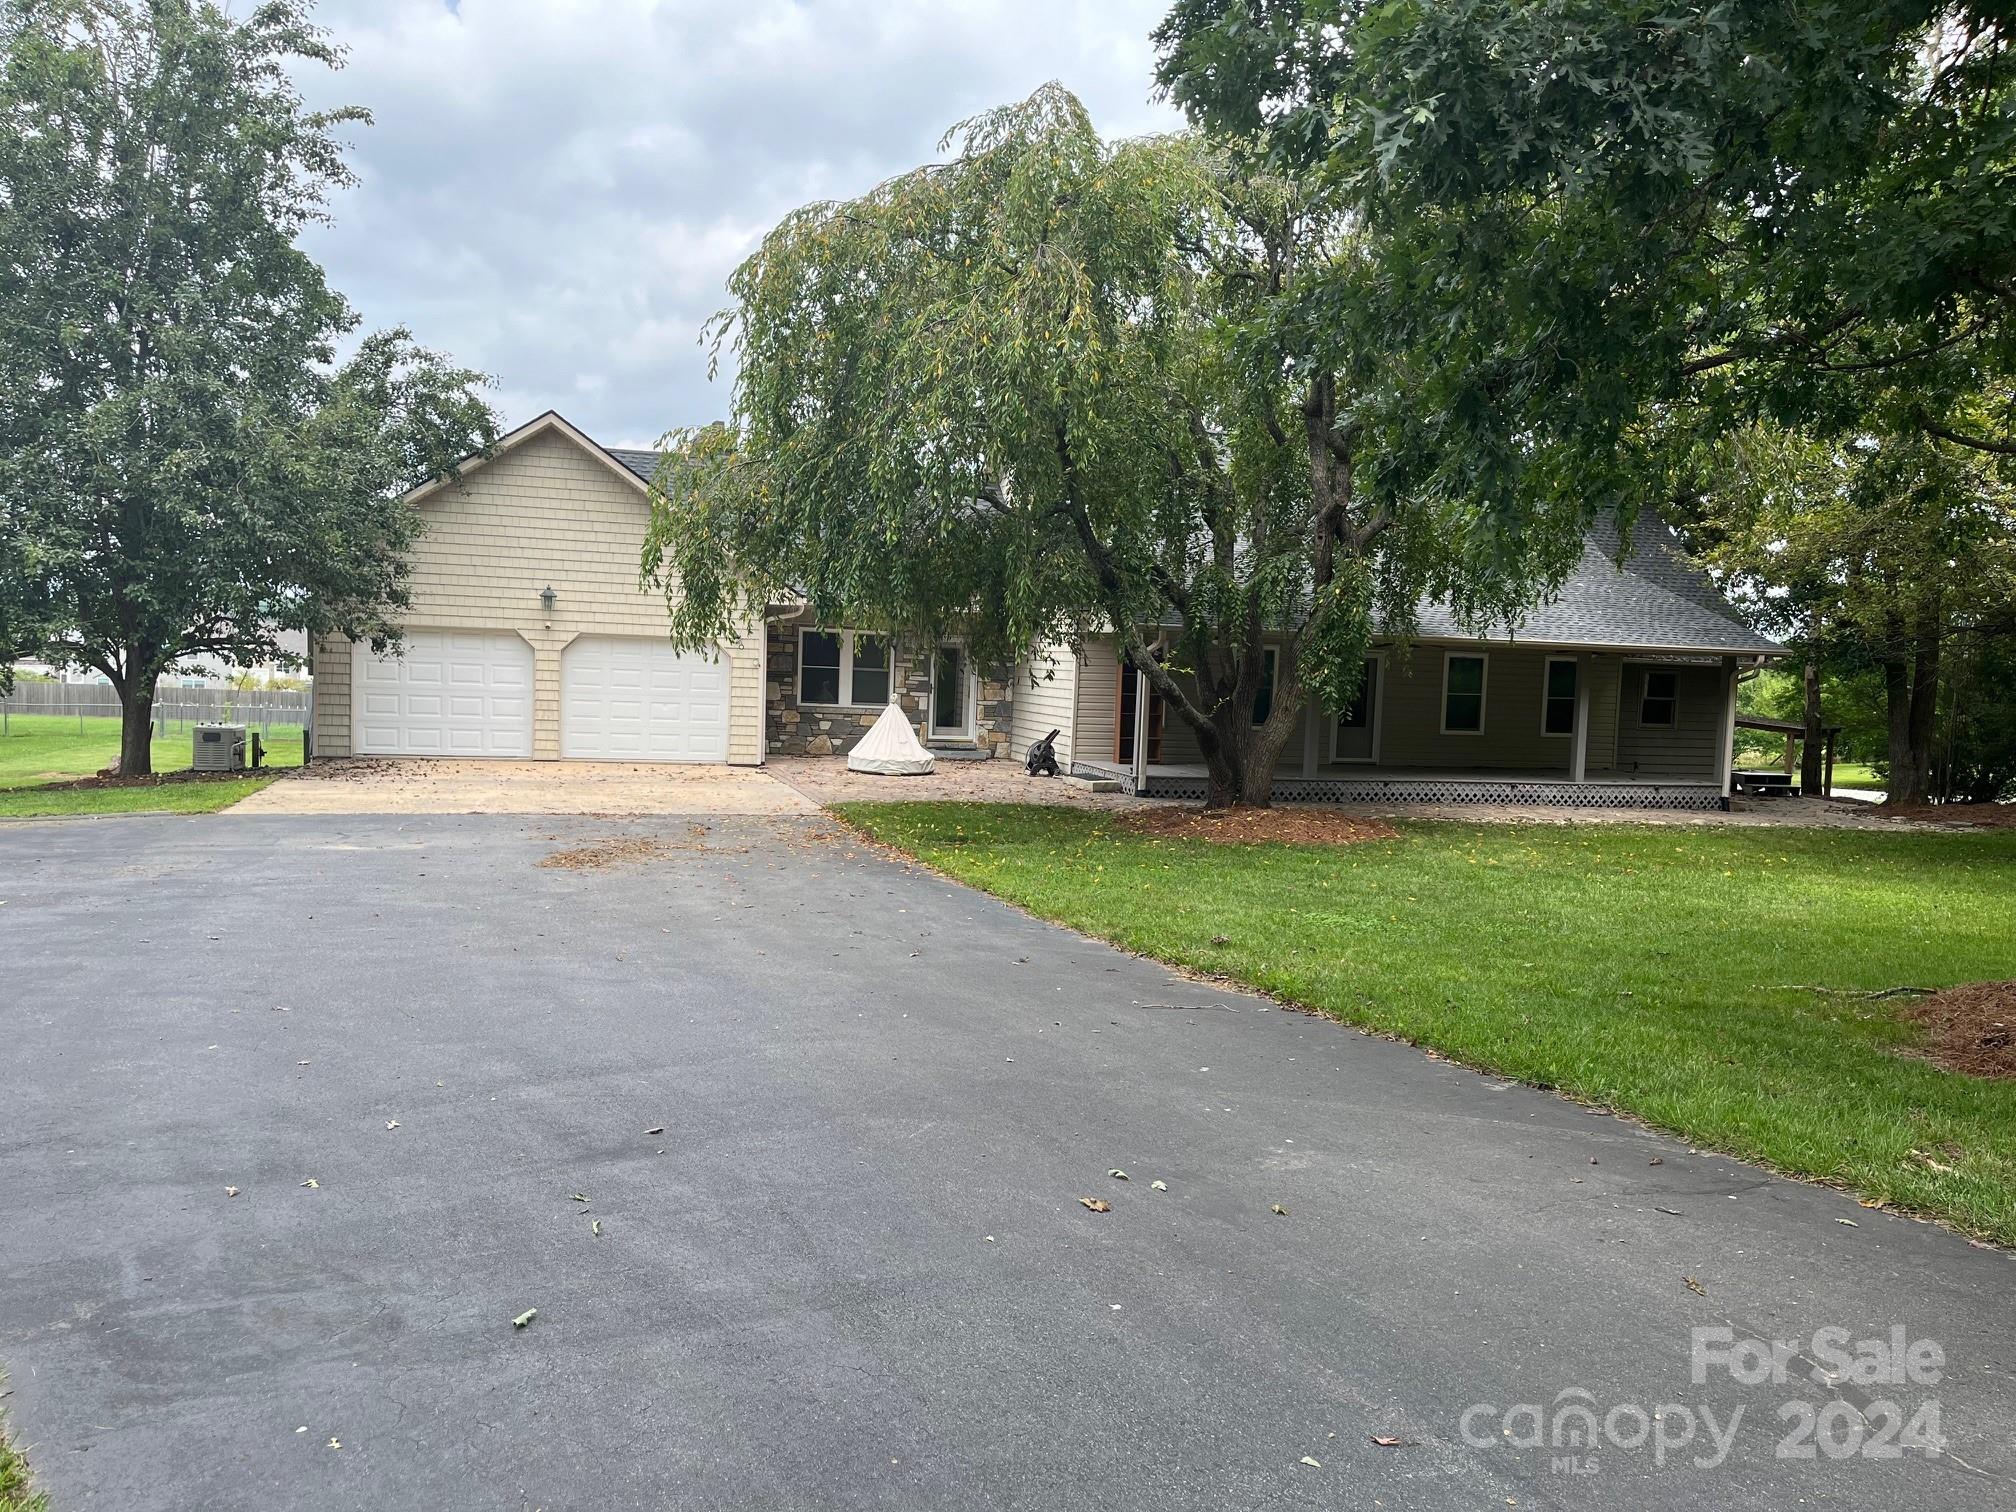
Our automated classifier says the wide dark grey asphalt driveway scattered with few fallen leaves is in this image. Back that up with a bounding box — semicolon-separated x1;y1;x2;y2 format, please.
0;814;2016;1512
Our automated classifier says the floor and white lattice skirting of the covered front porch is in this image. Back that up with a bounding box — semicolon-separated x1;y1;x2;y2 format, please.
1070;760;1726;810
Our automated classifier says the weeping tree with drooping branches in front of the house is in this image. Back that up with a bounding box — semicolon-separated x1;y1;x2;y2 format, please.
643;85;1558;804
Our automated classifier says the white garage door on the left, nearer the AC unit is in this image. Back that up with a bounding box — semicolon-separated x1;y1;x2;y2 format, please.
351;631;532;756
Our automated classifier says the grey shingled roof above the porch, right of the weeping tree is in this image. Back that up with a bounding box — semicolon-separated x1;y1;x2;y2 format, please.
1417;518;1784;655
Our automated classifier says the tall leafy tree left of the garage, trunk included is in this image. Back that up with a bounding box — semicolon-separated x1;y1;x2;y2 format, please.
0;0;496;770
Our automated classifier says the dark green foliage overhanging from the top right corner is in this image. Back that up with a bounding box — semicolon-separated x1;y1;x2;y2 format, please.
1157;0;2016;508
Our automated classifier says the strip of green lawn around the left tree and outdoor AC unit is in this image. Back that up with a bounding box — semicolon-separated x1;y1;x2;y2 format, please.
0;714;300;818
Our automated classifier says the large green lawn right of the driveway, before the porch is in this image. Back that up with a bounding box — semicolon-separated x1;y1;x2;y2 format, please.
839;804;2016;1244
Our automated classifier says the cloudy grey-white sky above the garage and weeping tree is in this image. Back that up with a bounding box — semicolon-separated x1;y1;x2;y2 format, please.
302;0;1177;446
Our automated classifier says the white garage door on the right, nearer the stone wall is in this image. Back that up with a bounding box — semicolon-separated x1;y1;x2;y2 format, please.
560;635;728;762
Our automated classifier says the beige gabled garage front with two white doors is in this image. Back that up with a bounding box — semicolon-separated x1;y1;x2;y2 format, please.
312;413;766;766
